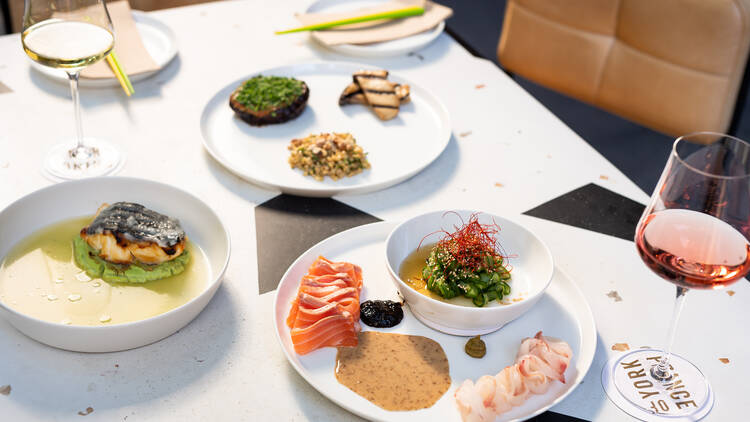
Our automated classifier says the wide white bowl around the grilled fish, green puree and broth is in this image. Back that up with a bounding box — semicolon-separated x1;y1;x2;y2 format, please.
0;177;230;352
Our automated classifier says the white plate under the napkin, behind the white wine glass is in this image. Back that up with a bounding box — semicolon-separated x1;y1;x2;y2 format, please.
29;10;177;88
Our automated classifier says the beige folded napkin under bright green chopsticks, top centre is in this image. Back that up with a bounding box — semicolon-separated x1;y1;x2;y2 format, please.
296;0;453;45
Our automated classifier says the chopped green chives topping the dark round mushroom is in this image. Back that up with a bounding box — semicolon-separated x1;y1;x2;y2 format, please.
235;75;304;111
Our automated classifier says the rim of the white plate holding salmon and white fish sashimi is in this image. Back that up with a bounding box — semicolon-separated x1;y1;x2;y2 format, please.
273;220;598;421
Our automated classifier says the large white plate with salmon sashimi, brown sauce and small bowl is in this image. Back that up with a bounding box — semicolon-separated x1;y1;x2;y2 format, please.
274;222;596;422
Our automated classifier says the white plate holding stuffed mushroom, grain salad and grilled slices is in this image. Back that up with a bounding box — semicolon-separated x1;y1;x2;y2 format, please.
201;62;451;197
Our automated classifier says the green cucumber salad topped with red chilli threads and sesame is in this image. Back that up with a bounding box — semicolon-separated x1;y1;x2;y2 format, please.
422;215;510;307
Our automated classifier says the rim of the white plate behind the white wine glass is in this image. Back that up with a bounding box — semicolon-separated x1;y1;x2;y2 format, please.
28;10;179;88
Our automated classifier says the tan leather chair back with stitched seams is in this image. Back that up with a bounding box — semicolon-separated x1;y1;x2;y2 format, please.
497;0;750;135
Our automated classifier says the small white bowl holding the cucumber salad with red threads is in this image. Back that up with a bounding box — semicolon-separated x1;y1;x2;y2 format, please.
385;210;554;336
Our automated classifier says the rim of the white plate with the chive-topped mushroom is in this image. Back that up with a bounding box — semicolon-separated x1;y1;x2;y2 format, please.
199;61;453;198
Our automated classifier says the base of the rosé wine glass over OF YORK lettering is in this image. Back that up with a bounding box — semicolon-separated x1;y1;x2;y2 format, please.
602;349;714;422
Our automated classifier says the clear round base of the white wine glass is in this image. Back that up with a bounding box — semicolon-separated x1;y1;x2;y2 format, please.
42;137;125;182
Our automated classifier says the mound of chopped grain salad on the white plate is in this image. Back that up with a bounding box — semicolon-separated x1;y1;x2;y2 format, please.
288;133;370;181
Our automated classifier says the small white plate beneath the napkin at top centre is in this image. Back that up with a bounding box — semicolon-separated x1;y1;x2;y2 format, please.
305;0;445;57
